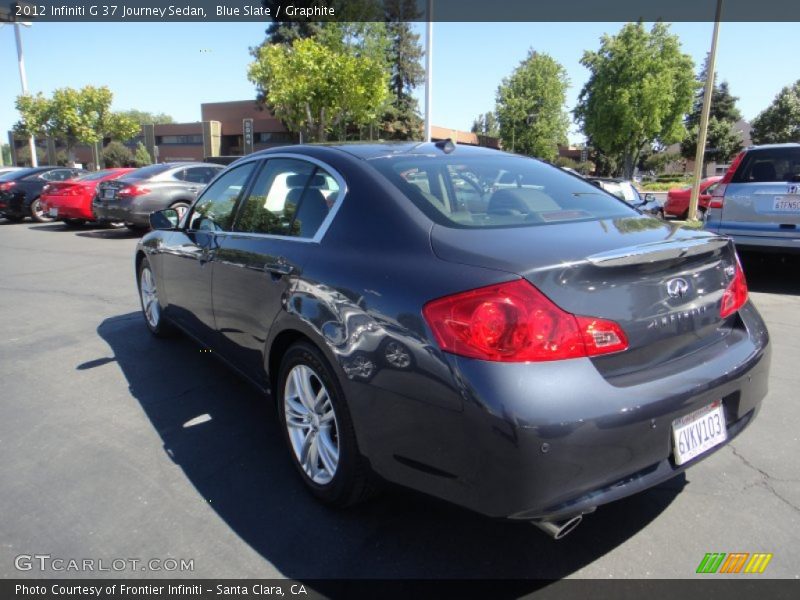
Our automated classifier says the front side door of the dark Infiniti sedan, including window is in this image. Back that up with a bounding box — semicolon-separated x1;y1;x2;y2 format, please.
161;163;255;345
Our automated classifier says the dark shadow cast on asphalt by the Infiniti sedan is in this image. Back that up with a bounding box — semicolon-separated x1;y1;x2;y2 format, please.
92;313;686;592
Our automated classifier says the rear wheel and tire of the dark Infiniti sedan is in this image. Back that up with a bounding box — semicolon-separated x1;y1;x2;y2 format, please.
276;342;375;507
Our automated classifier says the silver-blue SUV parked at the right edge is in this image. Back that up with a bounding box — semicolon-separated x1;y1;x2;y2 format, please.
705;144;800;252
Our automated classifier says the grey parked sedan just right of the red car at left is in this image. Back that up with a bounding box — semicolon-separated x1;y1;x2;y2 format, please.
92;162;225;229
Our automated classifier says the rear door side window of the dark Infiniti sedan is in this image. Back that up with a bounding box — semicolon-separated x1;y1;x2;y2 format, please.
235;158;339;238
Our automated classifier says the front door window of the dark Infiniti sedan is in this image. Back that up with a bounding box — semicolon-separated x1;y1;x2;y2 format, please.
187;161;256;231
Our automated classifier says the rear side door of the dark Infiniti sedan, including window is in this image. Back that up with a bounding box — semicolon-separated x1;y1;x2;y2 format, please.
213;157;344;382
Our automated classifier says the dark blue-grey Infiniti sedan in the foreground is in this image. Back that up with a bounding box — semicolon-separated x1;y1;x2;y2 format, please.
136;142;769;537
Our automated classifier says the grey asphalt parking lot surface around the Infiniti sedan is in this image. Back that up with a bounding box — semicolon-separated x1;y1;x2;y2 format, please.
0;220;800;580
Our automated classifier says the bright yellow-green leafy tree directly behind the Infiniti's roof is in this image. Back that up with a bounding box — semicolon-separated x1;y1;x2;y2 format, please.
248;36;388;142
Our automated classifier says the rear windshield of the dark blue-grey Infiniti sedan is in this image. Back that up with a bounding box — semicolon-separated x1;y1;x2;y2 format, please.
370;153;638;228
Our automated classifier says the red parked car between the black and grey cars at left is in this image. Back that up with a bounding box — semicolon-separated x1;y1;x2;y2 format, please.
40;169;136;227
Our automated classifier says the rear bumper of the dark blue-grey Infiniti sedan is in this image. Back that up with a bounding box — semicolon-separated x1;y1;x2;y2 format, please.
354;303;770;520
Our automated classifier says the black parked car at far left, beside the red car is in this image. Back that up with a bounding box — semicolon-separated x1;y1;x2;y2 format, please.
0;167;87;223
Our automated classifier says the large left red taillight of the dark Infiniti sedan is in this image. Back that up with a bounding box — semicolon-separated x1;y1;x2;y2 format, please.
422;279;628;362
